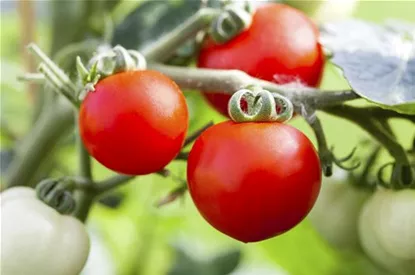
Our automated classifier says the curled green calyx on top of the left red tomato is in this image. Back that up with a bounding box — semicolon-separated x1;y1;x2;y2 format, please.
76;45;147;100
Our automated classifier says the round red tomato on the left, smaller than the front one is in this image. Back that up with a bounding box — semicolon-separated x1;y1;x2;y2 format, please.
79;70;188;175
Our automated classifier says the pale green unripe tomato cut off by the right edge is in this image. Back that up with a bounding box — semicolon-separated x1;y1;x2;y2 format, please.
359;189;415;275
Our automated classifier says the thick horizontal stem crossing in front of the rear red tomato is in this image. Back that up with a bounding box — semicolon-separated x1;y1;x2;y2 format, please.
148;63;359;109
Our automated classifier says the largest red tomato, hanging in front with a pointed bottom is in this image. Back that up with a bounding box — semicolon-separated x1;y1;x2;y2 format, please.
187;121;321;243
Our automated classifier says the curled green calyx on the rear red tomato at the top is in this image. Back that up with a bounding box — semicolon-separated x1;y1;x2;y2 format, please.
210;1;252;43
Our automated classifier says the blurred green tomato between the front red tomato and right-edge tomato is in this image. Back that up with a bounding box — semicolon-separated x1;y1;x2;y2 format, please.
308;170;371;251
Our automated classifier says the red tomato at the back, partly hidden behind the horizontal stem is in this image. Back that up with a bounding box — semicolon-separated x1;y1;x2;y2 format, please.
197;3;324;116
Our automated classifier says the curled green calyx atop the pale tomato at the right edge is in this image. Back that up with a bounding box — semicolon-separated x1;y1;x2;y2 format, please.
377;162;415;190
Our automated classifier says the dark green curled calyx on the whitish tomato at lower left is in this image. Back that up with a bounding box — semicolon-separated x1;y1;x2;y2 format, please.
36;179;75;214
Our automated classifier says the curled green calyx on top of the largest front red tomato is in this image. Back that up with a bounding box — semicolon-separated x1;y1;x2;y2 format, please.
228;86;294;122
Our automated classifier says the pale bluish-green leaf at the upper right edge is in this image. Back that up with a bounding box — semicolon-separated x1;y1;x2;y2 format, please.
320;20;415;114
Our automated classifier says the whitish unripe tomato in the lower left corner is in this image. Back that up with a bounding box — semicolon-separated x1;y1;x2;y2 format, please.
0;187;90;275
